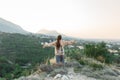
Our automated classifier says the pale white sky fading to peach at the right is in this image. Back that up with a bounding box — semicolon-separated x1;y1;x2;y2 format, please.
0;0;120;39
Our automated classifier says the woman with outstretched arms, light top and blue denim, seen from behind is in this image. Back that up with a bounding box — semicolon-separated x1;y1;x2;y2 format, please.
43;35;75;64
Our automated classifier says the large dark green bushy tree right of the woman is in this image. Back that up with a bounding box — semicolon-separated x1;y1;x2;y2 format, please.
84;42;114;63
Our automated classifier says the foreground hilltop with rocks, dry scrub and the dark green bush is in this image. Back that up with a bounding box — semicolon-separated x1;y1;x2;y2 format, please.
14;42;120;80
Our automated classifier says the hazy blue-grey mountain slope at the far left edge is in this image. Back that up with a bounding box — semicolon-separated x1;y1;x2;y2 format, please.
0;18;28;34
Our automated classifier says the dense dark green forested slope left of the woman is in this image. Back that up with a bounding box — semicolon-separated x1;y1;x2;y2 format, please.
0;33;54;80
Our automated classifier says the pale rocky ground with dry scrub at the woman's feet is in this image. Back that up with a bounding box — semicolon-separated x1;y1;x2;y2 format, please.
15;61;120;80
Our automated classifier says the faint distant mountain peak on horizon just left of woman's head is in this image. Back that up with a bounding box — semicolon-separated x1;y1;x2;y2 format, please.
37;29;66;37
